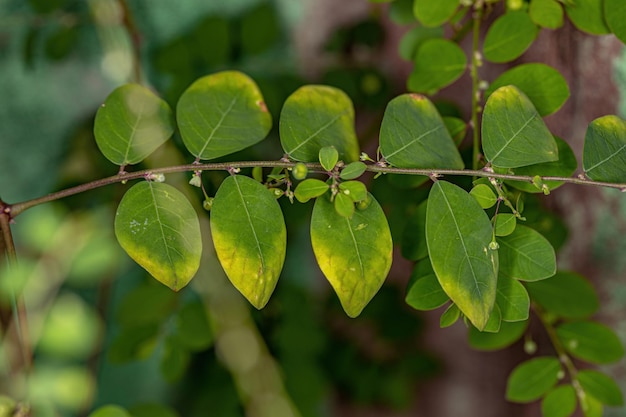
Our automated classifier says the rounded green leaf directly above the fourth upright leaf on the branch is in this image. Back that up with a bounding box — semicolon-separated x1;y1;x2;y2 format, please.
407;38;467;94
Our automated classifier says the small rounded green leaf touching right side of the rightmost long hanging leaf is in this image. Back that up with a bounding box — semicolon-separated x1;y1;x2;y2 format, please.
497;225;556;281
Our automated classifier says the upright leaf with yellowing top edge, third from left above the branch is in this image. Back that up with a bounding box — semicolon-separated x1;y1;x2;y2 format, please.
280;85;359;163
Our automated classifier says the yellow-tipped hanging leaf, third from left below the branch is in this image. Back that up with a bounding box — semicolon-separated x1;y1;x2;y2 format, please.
311;195;393;317
